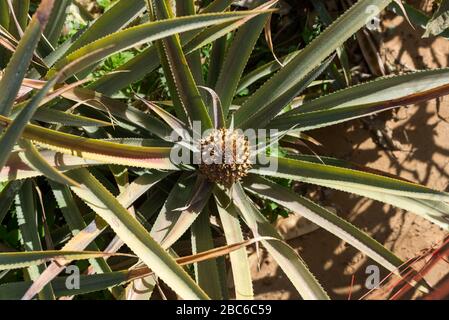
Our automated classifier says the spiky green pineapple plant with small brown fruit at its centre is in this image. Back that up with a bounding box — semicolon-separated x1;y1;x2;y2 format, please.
0;0;449;299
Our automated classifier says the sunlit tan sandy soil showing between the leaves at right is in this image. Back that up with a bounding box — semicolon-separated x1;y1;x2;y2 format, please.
247;1;449;299
